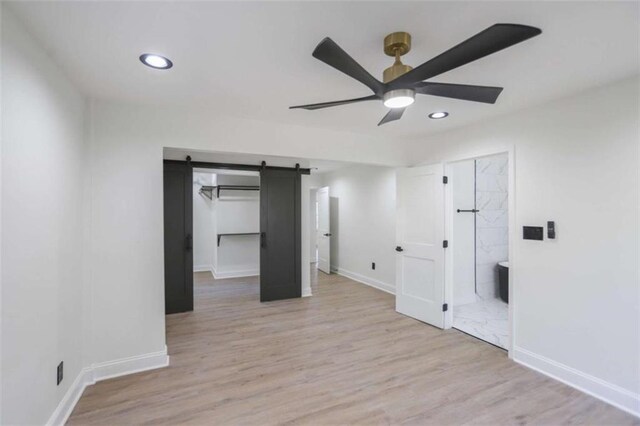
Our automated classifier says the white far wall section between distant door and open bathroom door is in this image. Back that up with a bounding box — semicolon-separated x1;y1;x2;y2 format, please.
319;166;396;292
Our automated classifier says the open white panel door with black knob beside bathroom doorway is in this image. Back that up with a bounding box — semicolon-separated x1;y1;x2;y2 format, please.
396;164;445;328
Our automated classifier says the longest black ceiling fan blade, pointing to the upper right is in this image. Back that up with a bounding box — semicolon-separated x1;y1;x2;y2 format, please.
389;24;542;88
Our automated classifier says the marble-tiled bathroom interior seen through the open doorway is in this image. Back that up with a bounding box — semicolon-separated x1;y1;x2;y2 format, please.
450;153;509;349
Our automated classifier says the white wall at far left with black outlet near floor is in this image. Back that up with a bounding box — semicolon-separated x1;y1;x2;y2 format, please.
0;8;85;424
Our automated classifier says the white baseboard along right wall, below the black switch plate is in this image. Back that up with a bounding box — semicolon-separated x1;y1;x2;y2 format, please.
513;347;640;417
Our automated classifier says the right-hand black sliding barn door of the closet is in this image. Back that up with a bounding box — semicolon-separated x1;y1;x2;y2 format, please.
260;169;302;302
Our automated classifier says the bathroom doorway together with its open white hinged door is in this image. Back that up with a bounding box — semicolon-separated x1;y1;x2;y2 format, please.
395;151;514;350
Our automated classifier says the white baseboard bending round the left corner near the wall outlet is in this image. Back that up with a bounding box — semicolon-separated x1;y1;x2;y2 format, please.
47;346;169;426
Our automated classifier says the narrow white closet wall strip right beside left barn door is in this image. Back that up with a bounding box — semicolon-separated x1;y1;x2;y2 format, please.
193;172;217;271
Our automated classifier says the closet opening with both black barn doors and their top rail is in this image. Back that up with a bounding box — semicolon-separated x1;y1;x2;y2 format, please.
164;156;310;314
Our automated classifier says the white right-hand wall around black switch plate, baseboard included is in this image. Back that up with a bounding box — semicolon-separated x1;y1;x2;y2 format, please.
408;78;640;414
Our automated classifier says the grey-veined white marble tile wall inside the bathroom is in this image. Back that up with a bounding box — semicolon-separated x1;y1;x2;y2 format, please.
476;153;509;299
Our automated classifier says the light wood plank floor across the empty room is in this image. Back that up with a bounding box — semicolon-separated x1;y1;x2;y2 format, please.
69;273;640;425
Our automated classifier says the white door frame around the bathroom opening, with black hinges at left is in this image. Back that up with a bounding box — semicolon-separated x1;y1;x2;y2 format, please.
443;145;517;358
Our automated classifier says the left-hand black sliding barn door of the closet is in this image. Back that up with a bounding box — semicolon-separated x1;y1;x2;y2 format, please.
164;162;193;314
